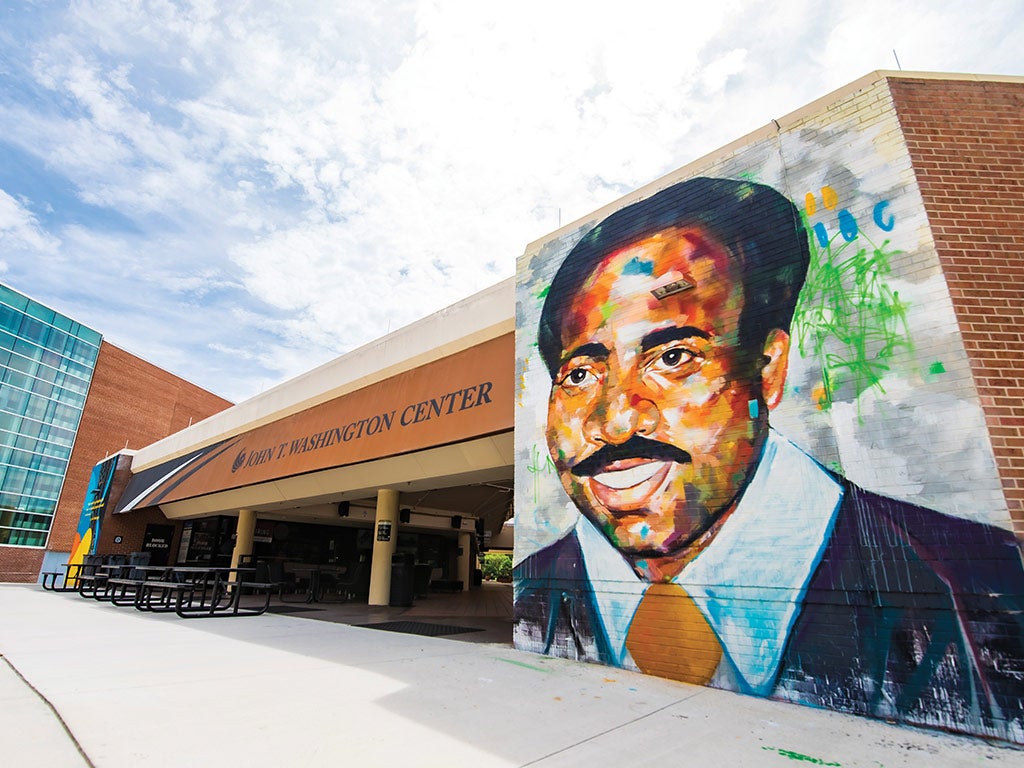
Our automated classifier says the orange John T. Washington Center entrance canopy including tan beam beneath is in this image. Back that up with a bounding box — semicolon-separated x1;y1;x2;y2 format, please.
116;334;515;516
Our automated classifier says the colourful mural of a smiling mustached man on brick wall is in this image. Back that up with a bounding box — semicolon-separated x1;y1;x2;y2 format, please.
514;81;1024;740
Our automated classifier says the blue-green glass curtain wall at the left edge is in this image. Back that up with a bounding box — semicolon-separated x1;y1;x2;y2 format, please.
0;285;101;547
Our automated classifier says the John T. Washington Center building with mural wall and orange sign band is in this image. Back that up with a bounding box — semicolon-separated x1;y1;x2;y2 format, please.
36;73;1024;742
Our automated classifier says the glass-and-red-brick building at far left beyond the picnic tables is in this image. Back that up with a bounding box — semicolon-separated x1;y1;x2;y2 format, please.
0;286;231;582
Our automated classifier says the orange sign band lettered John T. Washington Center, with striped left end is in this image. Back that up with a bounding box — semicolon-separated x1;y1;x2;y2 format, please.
119;334;515;511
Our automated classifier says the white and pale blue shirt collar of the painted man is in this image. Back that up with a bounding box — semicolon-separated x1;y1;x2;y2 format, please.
575;431;843;695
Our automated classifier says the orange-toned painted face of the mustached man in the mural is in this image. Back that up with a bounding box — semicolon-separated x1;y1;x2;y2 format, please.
547;227;788;557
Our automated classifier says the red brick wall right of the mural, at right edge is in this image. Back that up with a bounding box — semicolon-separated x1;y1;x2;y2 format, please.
890;78;1024;537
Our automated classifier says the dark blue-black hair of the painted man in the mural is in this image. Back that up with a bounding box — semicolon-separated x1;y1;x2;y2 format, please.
538;177;810;379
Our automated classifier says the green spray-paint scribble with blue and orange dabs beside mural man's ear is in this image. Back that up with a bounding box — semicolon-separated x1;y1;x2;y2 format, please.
793;187;912;416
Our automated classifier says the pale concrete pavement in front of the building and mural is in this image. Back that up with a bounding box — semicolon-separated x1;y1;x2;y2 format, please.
0;585;1024;768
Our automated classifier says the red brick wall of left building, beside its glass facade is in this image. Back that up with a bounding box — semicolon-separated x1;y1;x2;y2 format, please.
0;341;231;582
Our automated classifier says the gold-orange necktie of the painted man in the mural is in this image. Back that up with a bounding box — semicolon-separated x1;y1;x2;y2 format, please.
626;583;722;685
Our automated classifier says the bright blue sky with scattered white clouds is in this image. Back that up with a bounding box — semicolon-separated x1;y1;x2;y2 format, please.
0;0;1024;401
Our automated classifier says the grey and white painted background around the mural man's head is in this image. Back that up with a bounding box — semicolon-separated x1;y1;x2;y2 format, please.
515;78;1010;561
